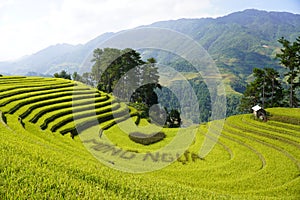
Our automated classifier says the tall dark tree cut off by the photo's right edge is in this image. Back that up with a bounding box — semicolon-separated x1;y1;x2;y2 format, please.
276;36;300;108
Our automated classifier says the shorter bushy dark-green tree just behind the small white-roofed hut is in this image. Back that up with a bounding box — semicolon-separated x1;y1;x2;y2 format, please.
239;68;283;112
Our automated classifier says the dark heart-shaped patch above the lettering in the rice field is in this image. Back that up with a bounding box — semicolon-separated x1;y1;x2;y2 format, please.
129;132;166;145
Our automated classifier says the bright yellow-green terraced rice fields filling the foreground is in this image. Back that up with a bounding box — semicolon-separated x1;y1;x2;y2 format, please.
0;76;300;199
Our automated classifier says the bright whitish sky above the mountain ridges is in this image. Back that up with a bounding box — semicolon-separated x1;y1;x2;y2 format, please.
0;0;300;61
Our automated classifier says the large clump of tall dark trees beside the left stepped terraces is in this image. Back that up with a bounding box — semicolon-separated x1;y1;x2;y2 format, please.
91;48;160;107
